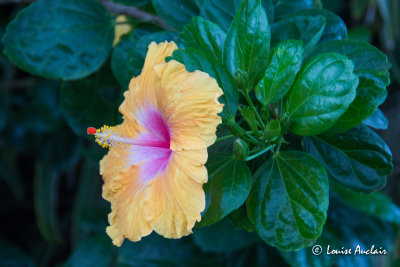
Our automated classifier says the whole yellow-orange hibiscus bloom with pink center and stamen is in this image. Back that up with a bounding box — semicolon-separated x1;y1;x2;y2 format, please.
89;42;223;246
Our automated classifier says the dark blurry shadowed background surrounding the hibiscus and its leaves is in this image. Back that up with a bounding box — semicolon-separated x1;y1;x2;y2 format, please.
0;0;400;267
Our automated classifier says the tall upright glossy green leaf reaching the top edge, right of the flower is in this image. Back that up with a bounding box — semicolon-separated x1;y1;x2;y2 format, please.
223;0;271;87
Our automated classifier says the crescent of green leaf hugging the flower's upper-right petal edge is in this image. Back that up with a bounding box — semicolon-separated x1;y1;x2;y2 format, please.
172;48;239;120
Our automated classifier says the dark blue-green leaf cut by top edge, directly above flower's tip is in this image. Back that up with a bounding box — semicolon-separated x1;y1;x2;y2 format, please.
152;0;200;30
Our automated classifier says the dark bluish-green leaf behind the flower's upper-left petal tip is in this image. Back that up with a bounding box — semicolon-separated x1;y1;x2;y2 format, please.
111;28;177;89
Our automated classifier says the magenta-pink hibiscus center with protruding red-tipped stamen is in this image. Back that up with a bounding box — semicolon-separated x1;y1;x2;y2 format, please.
88;105;172;186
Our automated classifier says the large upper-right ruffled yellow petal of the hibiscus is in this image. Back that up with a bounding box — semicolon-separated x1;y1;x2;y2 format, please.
153;60;223;151
